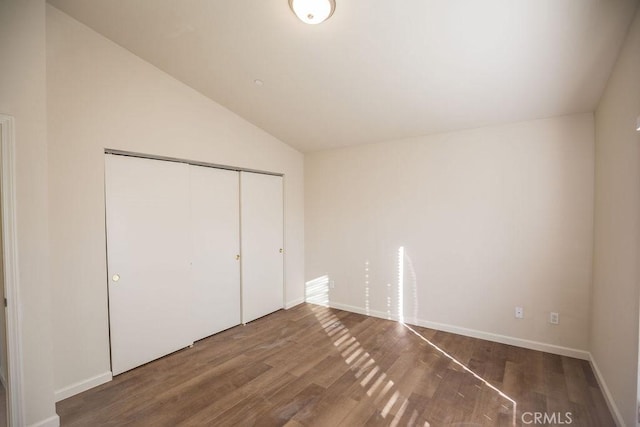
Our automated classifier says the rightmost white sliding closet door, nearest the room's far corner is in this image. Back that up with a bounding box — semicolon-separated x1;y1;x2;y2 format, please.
240;172;284;323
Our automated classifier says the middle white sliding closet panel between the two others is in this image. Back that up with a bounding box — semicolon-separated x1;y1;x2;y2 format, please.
190;166;241;340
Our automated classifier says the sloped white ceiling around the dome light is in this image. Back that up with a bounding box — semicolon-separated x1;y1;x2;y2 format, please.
49;0;637;151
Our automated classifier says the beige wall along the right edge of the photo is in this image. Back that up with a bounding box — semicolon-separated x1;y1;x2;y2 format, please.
591;6;640;426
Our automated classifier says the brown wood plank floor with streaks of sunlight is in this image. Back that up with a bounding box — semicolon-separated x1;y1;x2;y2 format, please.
57;304;615;427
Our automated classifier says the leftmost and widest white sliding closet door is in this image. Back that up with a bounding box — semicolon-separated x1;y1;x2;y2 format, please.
105;154;193;375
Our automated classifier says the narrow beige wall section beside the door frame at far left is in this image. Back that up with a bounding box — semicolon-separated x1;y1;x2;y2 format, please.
0;0;57;424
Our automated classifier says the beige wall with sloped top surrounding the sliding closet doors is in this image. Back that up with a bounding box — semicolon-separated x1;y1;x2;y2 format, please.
47;6;304;400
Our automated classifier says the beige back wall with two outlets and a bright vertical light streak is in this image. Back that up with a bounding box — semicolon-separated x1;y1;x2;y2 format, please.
305;114;594;356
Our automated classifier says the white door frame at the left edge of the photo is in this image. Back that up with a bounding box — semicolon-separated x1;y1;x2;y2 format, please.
0;114;25;426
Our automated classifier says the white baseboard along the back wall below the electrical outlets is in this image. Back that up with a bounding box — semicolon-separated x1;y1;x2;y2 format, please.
329;302;591;360
